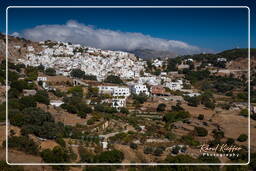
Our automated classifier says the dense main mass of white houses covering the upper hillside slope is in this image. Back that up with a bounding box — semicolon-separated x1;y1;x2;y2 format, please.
18;42;146;81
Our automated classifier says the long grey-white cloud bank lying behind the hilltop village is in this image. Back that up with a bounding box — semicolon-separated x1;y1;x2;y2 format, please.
18;20;201;54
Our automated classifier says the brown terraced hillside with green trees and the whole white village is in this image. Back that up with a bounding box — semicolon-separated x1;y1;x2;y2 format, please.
0;34;256;169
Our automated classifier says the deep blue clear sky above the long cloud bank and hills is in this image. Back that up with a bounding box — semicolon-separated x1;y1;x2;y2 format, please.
1;0;254;52
